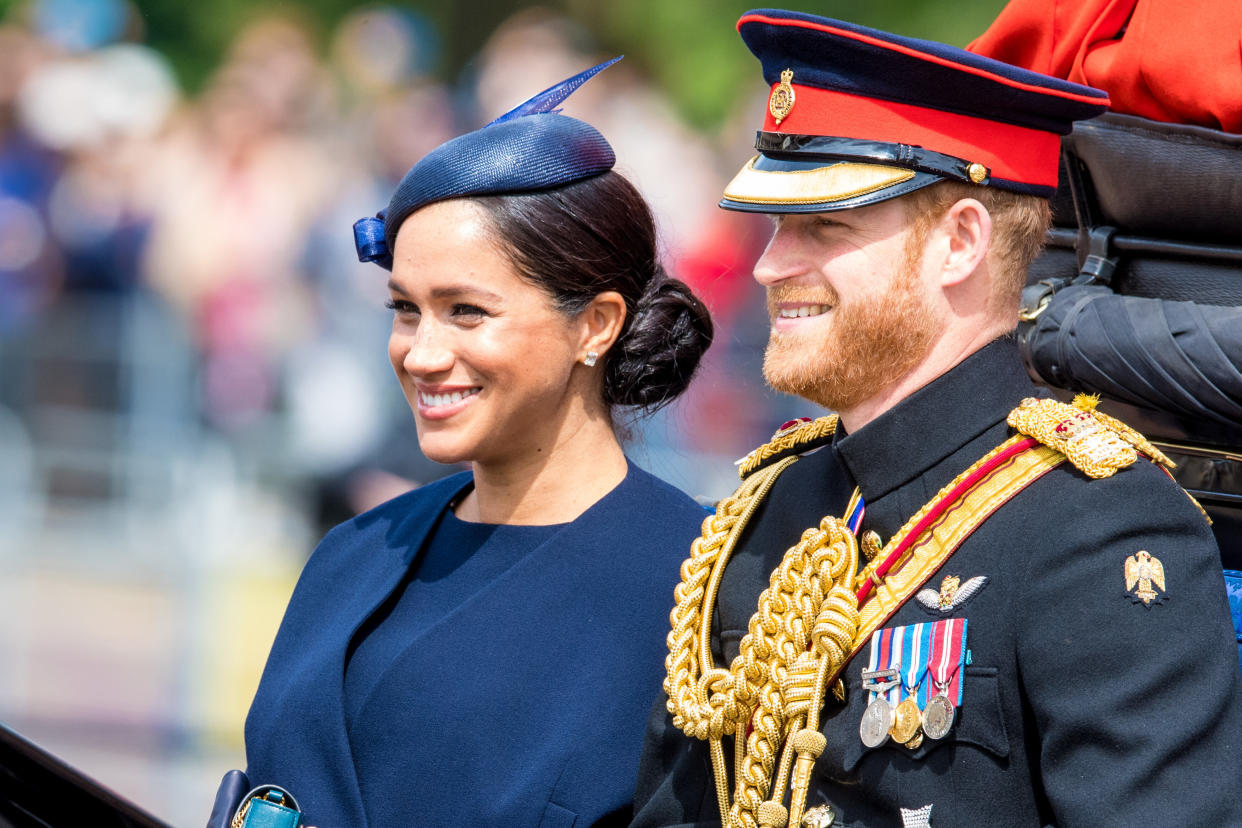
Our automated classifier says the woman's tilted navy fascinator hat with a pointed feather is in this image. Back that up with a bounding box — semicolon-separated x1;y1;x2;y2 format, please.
354;57;621;271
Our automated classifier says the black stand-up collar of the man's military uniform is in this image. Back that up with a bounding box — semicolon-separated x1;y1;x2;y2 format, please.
833;336;1035;502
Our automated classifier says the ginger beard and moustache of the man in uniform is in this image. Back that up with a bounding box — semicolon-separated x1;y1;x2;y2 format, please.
764;245;941;411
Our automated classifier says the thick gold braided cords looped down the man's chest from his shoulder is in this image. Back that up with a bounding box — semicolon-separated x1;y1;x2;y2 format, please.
664;434;858;828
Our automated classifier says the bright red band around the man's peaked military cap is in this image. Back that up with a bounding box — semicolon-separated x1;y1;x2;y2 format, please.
764;83;1061;187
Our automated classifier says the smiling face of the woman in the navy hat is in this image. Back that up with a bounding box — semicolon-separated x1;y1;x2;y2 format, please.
389;200;585;464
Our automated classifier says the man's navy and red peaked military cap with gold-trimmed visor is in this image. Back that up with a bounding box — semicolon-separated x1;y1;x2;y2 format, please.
720;9;1108;212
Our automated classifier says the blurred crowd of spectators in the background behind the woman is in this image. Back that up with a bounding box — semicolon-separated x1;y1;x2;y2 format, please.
0;0;1002;826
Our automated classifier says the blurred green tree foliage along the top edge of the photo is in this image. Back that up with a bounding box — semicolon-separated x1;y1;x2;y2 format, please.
0;0;1005;129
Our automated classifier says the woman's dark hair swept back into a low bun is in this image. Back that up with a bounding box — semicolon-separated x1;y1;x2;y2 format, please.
473;170;712;411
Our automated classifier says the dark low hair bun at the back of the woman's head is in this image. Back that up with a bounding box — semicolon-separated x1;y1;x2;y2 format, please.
604;271;713;411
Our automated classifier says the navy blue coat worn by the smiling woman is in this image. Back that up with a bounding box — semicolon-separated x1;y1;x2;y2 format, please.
246;466;705;828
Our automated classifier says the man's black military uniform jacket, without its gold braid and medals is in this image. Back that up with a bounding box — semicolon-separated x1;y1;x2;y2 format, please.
633;339;1242;828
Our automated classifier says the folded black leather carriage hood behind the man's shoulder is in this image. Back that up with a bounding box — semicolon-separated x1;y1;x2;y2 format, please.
1018;114;1242;570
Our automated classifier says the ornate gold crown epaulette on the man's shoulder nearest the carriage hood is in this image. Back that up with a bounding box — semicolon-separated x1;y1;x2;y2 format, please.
1007;394;1174;478
